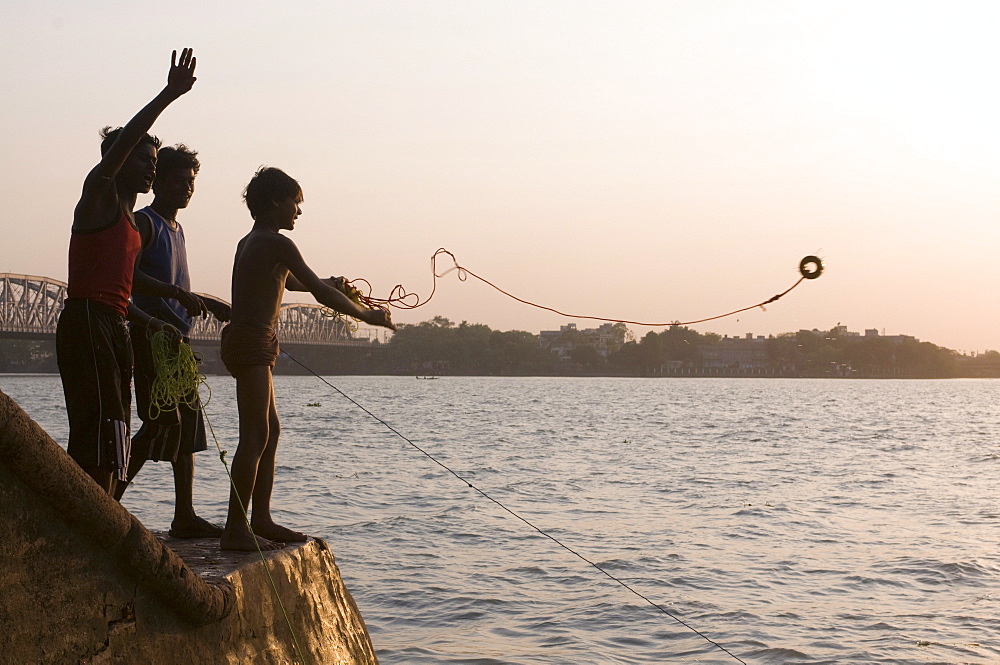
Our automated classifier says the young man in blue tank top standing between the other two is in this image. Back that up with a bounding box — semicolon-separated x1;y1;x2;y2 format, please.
115;144;229;538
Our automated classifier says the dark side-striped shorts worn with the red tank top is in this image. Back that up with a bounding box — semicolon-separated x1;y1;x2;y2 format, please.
56;298;132;480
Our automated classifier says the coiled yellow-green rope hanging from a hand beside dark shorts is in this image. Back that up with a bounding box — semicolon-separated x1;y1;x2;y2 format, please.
149;329;212;418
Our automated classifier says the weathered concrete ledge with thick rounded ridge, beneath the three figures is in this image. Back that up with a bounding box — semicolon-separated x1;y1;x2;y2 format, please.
0;392;378;665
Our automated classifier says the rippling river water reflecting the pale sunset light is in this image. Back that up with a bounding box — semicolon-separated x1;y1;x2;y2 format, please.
0;375;1000;665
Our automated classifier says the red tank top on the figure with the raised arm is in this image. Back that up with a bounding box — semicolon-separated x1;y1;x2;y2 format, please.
66;212;142;316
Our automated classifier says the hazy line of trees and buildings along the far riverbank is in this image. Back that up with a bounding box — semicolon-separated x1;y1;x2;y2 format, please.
0;316;1000;378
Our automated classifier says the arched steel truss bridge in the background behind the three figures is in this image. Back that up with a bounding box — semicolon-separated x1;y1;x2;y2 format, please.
0;273;387;346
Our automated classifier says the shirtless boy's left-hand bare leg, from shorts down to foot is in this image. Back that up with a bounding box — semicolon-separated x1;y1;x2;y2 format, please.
219;365;283;551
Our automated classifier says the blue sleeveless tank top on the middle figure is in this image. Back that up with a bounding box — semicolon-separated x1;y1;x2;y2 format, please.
132;206;192;335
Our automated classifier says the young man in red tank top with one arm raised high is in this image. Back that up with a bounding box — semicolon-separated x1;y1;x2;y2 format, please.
56;49;201;494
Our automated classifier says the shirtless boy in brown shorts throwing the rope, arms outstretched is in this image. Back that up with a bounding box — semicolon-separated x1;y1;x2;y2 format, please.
220;167;395;551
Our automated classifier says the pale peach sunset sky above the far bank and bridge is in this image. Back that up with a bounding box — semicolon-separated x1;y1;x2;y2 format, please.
0;0;1000;352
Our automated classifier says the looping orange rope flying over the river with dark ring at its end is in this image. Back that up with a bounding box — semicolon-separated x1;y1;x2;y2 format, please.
344;247;823;328
